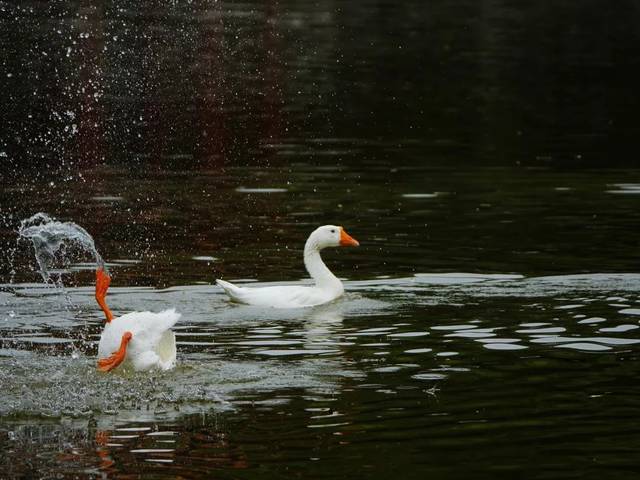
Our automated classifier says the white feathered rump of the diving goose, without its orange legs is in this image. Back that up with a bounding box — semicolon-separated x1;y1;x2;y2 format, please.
98;309;180;371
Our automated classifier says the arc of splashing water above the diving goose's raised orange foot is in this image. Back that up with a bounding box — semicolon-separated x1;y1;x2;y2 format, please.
18;212;106;284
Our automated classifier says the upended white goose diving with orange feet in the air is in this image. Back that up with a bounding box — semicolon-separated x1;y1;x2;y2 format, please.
96;268;180;372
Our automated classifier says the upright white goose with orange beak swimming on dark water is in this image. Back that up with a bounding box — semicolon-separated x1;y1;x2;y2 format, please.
216;225;360;308
